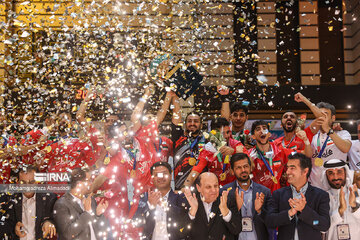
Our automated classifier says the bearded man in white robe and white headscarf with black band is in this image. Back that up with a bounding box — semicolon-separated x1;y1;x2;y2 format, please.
322;159;360;240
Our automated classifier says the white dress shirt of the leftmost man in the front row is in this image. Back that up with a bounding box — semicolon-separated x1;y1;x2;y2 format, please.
21;194;36;240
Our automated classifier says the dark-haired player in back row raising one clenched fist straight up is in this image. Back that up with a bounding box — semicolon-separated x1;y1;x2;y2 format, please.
217;85;253;150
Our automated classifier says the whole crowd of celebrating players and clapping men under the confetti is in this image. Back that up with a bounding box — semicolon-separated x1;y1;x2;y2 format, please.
0;86;360;240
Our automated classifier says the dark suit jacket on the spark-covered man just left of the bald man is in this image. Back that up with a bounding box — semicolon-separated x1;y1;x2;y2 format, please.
133;190;190;240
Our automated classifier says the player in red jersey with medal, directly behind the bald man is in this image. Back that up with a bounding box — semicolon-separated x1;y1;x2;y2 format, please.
190;117;248;186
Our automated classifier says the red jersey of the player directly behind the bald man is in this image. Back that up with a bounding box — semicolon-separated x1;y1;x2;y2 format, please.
192;138;248;186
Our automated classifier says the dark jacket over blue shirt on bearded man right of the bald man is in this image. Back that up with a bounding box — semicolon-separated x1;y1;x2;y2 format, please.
220;180;271;240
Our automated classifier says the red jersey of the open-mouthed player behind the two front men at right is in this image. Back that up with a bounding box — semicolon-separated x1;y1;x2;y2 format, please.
250;143;293;192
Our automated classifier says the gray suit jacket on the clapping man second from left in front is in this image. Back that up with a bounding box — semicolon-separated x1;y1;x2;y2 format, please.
54;192;111;240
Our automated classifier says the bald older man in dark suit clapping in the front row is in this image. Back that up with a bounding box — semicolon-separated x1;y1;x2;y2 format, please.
185;172;242;239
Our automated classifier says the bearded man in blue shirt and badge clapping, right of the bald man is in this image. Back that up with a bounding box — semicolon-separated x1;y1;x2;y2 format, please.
222;153;271;240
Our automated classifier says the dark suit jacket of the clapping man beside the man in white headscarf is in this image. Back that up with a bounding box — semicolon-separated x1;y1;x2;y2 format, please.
266;183;330;240
